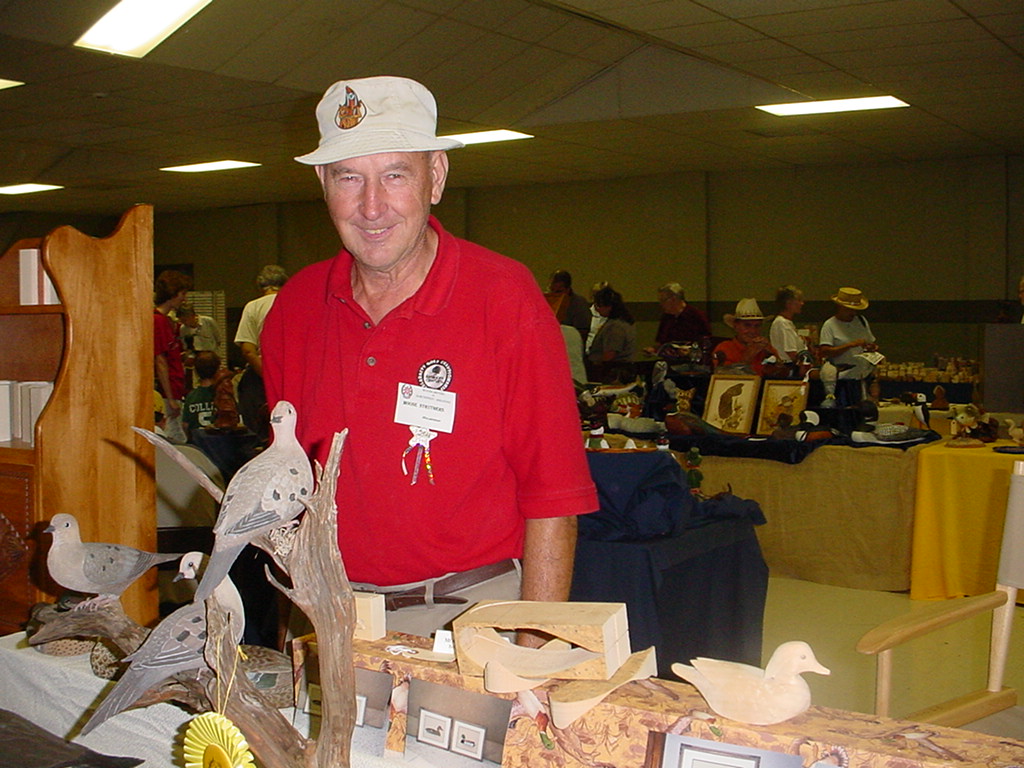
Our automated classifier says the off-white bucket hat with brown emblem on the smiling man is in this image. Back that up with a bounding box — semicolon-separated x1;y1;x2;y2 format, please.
296;76;463;165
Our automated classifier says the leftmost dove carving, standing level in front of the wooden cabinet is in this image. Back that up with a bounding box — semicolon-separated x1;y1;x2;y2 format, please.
45;512;181;610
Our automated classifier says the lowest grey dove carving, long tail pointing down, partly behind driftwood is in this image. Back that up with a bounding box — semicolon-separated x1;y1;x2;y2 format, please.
82;552;245;736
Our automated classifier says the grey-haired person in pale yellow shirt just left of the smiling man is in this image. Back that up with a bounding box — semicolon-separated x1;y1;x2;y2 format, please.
234;264;288;444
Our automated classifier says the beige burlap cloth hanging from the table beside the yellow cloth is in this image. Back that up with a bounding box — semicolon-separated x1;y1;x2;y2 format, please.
700;444;927;591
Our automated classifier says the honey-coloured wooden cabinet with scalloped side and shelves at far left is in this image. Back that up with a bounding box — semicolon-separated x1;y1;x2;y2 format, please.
0;206;158;634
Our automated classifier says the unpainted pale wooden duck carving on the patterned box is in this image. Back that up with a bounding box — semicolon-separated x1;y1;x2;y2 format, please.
672;640;830;725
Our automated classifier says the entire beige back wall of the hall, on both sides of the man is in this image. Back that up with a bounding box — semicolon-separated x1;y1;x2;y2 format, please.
140;154;1024;359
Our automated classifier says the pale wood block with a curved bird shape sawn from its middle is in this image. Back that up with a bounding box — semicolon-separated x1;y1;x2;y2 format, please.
453;600;630;680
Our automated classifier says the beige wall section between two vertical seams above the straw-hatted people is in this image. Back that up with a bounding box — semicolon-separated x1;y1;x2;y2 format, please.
708;159;1007;300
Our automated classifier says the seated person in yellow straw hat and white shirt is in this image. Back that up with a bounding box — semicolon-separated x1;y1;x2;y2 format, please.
818;288;879;408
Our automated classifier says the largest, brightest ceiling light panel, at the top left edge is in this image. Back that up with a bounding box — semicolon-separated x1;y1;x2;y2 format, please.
75;0;210;58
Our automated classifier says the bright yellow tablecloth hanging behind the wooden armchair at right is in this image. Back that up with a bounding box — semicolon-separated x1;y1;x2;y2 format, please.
910;440;1024;600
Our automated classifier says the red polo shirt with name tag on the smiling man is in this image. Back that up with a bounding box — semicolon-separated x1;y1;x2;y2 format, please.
260;217;598;585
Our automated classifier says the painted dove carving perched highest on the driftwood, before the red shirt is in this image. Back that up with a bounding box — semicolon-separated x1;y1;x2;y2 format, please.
196;400;313;600
